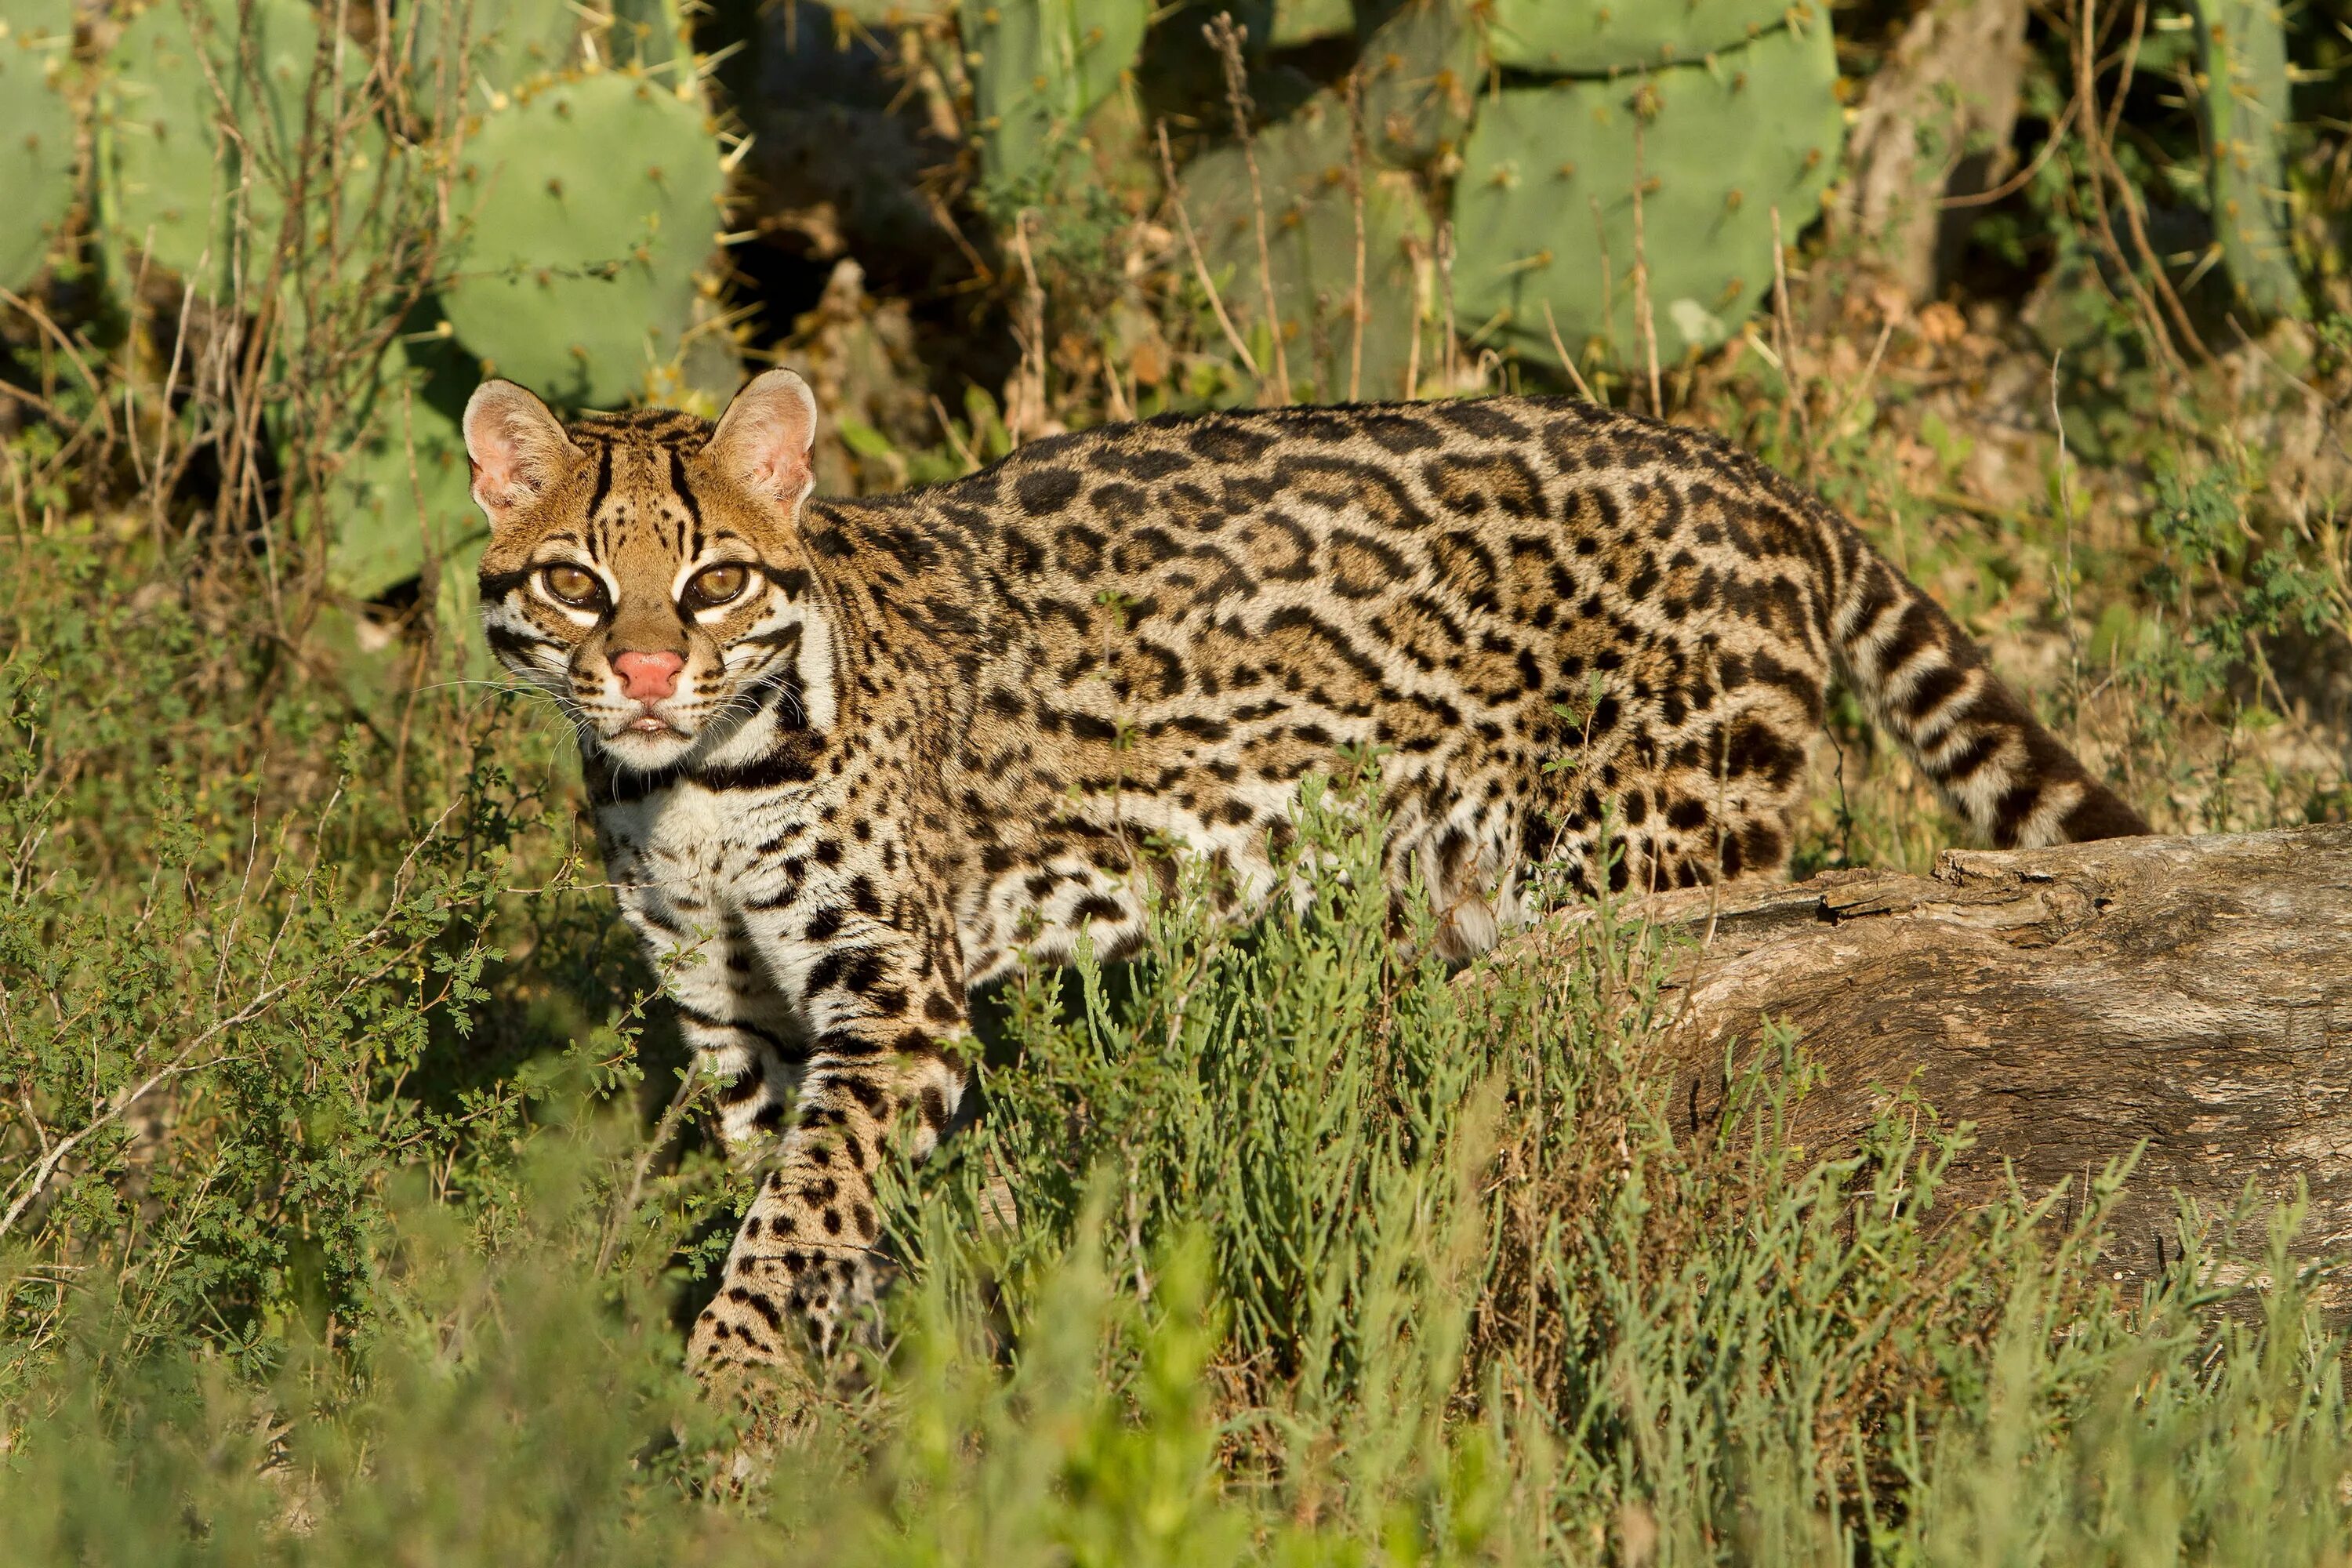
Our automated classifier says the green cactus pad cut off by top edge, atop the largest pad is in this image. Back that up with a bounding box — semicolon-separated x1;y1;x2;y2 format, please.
1486;0;1797;75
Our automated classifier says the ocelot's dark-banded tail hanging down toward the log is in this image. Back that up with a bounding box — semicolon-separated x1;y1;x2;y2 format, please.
1828;517;2152;848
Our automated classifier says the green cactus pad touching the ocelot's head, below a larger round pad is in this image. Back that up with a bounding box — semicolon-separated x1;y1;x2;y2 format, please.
327;341;485;600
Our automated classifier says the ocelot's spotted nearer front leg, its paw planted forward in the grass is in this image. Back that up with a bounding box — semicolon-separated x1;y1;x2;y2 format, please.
687;902;969;1368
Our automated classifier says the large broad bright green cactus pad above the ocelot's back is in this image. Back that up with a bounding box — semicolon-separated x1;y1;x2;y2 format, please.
1454;14;1844;373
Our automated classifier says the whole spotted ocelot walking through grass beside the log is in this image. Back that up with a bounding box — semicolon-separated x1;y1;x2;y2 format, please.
466;372;2147;1363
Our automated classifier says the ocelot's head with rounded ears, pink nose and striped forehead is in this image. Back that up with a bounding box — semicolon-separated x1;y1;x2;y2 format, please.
466;369;833;771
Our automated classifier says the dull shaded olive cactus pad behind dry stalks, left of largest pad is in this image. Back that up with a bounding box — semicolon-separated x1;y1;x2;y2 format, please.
1183;92;1430;402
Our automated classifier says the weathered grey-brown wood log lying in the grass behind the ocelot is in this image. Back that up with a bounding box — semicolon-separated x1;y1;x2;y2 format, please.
1529;825;2352;1305
